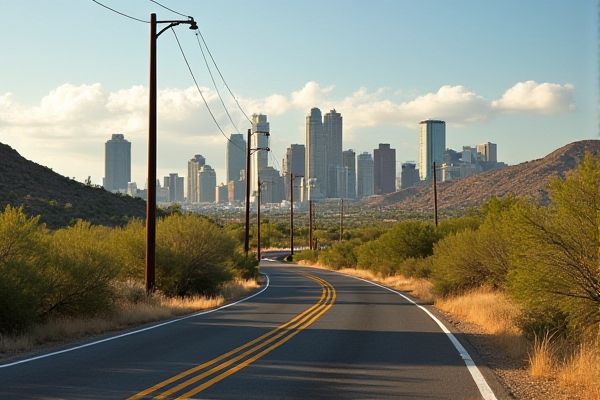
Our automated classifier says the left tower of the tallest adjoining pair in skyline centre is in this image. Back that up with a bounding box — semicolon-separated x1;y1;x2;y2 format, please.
304;107;328;200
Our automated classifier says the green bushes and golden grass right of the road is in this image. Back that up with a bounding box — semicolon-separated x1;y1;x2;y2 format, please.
295;154;600;399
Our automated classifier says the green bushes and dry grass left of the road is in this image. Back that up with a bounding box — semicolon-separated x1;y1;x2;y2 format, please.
0;206;258;353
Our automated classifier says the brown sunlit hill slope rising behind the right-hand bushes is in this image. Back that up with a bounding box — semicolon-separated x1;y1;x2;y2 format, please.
368;140;600;212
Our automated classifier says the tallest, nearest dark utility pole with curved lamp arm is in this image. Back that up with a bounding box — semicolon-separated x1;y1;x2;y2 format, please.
146;13;198;293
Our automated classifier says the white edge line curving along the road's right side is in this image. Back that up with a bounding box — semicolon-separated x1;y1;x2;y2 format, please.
316;270;497;400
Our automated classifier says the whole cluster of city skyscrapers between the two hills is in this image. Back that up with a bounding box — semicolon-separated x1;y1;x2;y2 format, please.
103;112;505;208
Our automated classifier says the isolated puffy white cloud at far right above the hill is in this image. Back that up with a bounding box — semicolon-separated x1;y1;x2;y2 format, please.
492;81;575;114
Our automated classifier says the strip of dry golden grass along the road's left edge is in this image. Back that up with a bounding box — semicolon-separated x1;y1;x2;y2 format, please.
0;280;259;355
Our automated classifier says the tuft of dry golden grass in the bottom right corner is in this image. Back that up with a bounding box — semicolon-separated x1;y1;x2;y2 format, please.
558;342;600;400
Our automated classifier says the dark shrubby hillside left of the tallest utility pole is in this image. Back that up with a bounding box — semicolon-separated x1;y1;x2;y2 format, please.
0;143;146;227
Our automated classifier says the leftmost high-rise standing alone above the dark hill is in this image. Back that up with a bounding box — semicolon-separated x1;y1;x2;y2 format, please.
102;133;131;193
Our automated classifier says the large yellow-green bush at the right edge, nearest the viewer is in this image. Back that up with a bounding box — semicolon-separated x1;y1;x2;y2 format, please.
509;154;600;335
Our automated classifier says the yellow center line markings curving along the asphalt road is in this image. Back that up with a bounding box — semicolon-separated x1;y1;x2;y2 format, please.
129;274;336;400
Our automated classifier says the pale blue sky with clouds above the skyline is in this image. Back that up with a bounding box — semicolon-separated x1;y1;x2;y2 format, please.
0;0;599;187
